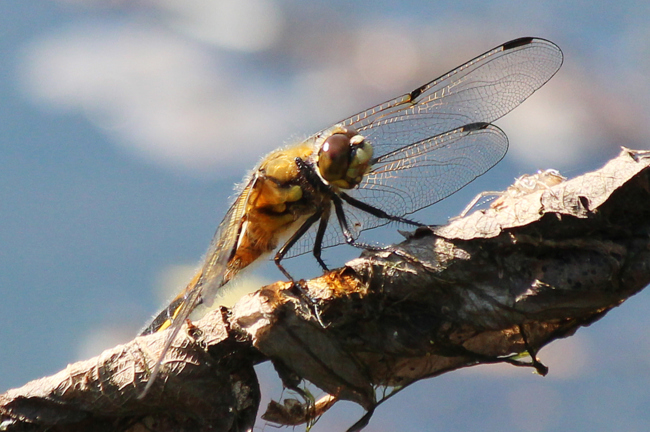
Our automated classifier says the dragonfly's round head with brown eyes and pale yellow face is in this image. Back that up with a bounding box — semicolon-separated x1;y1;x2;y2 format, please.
317;126;372;189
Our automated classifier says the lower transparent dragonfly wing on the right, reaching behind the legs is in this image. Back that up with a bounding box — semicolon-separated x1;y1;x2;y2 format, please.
286;123;508;257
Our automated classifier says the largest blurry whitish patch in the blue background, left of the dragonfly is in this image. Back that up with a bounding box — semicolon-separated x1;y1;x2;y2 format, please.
21;23;289;176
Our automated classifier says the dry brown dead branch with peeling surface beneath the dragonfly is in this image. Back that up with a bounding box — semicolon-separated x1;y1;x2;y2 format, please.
0;149;650;431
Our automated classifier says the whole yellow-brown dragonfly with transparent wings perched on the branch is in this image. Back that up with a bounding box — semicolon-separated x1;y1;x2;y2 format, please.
142;37;563;395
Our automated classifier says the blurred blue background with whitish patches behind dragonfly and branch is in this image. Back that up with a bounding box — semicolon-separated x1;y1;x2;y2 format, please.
0;0;650;432
